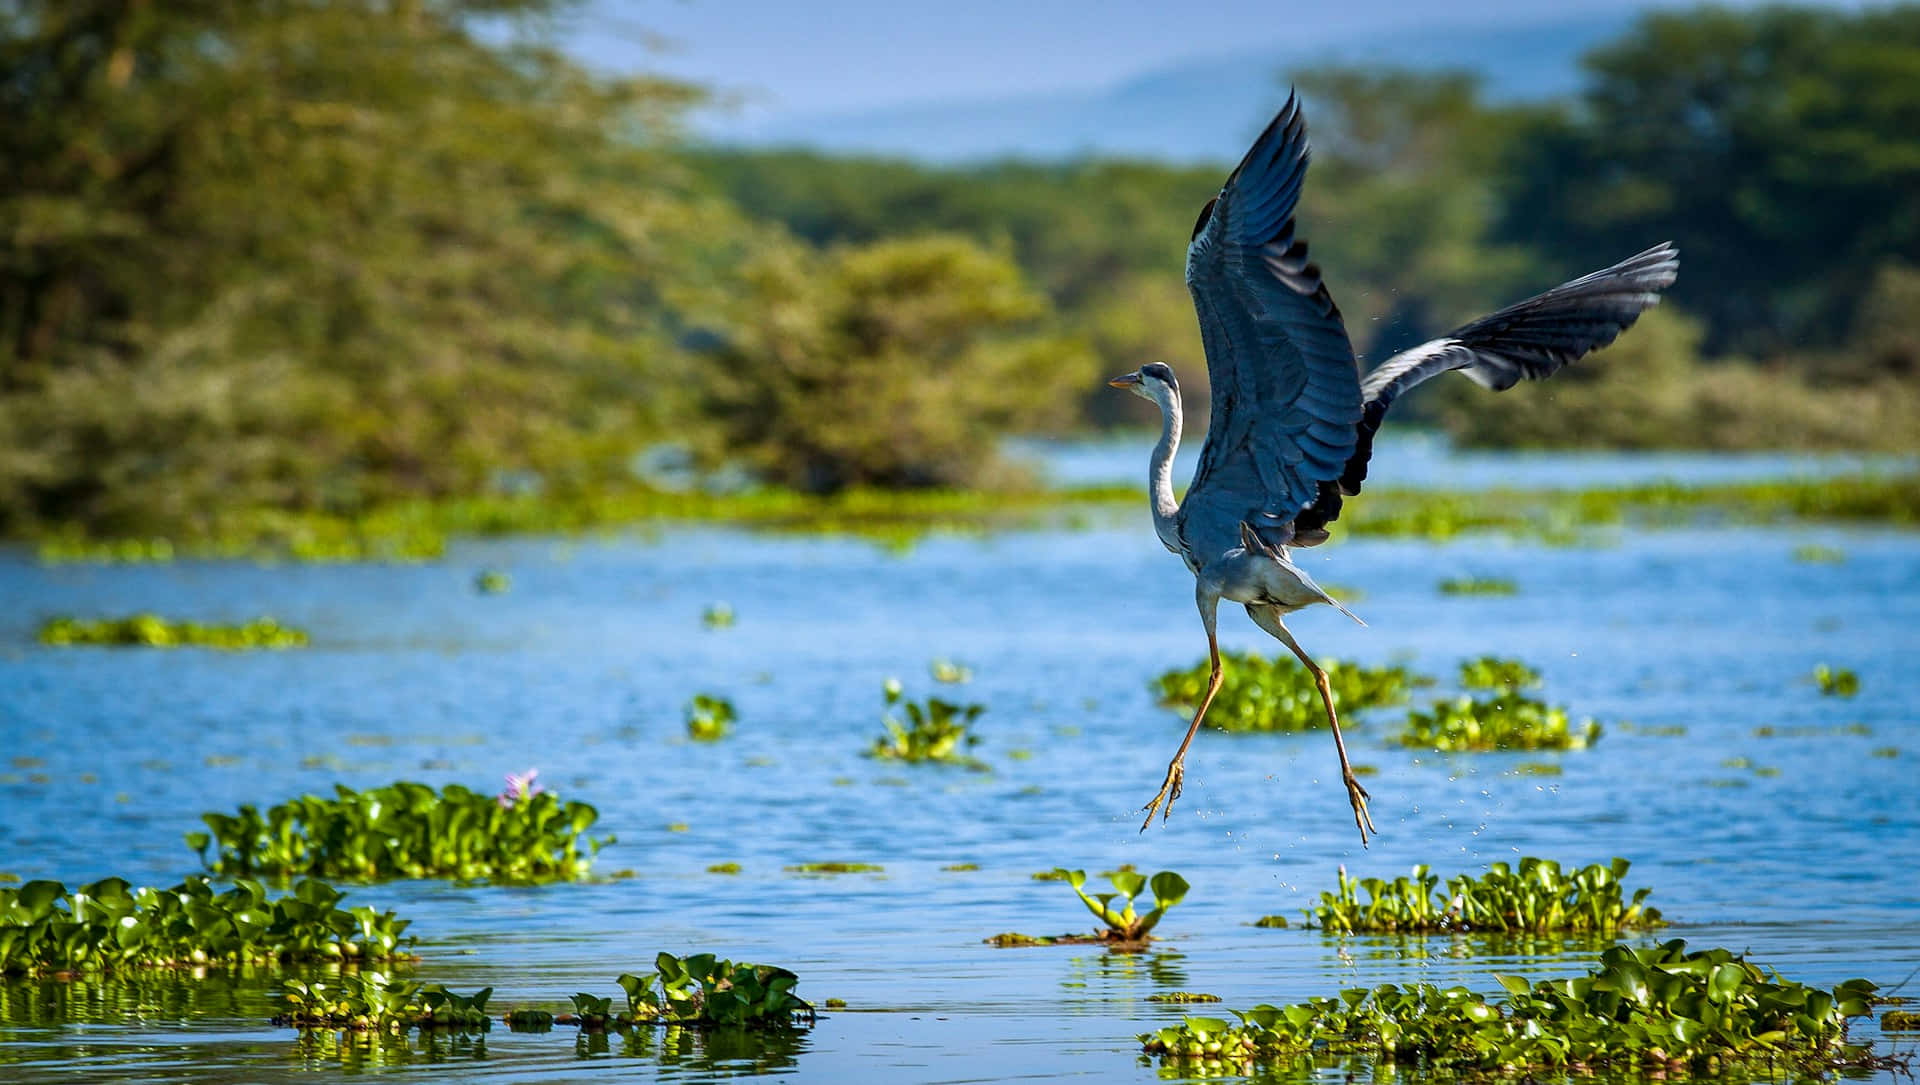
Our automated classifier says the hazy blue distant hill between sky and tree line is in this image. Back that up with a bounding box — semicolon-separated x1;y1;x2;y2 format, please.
683;13;1634;161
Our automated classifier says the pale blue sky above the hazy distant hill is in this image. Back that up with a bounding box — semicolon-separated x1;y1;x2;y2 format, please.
568;0;1851;117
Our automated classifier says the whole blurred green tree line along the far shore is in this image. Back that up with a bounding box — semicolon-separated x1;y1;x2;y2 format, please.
0;0;1920;534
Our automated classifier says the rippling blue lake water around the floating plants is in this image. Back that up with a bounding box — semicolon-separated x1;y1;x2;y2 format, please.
0;449;1920;1081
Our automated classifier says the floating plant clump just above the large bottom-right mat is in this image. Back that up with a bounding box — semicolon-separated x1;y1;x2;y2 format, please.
1306;856;1665;933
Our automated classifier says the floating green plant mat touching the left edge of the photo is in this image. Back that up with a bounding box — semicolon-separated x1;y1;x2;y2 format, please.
0;876;413;976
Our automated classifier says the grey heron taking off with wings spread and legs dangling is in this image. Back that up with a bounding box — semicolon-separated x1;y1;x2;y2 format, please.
1108;88;1680;845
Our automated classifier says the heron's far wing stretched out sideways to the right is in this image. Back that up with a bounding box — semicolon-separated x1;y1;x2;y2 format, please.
1304;242;1680;503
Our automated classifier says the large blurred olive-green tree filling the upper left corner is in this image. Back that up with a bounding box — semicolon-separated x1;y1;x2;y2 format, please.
0;0;735;534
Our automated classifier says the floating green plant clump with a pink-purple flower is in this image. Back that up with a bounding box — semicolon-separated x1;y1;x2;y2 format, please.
186;772;612;883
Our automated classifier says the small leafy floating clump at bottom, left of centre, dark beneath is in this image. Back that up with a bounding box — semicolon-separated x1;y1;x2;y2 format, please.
620;952;814;1027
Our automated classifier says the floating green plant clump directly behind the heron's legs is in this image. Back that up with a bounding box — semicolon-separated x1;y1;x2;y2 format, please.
1152;651;1427;732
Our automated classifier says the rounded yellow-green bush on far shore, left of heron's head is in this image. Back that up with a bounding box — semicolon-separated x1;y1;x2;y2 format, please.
701;236;1096;494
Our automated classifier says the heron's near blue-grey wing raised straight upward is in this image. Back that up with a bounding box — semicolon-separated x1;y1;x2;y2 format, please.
1179;96;1361;563
